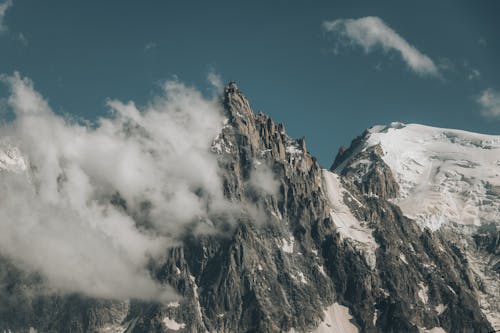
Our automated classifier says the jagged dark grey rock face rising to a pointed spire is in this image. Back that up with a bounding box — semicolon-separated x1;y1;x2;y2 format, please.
0;83;500;333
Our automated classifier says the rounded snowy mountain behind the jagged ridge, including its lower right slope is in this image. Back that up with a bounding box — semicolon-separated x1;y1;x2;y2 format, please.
332;123;500;326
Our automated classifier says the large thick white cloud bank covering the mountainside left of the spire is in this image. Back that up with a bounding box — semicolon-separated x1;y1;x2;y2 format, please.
0;73;230;300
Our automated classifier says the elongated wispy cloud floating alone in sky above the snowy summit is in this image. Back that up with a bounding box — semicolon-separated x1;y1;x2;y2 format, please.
323;16;439;76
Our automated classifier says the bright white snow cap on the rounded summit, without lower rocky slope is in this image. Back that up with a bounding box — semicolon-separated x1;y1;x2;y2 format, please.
336;123;500;230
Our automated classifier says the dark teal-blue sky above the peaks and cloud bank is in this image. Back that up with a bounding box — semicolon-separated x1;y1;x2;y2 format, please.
0;0;500;167
